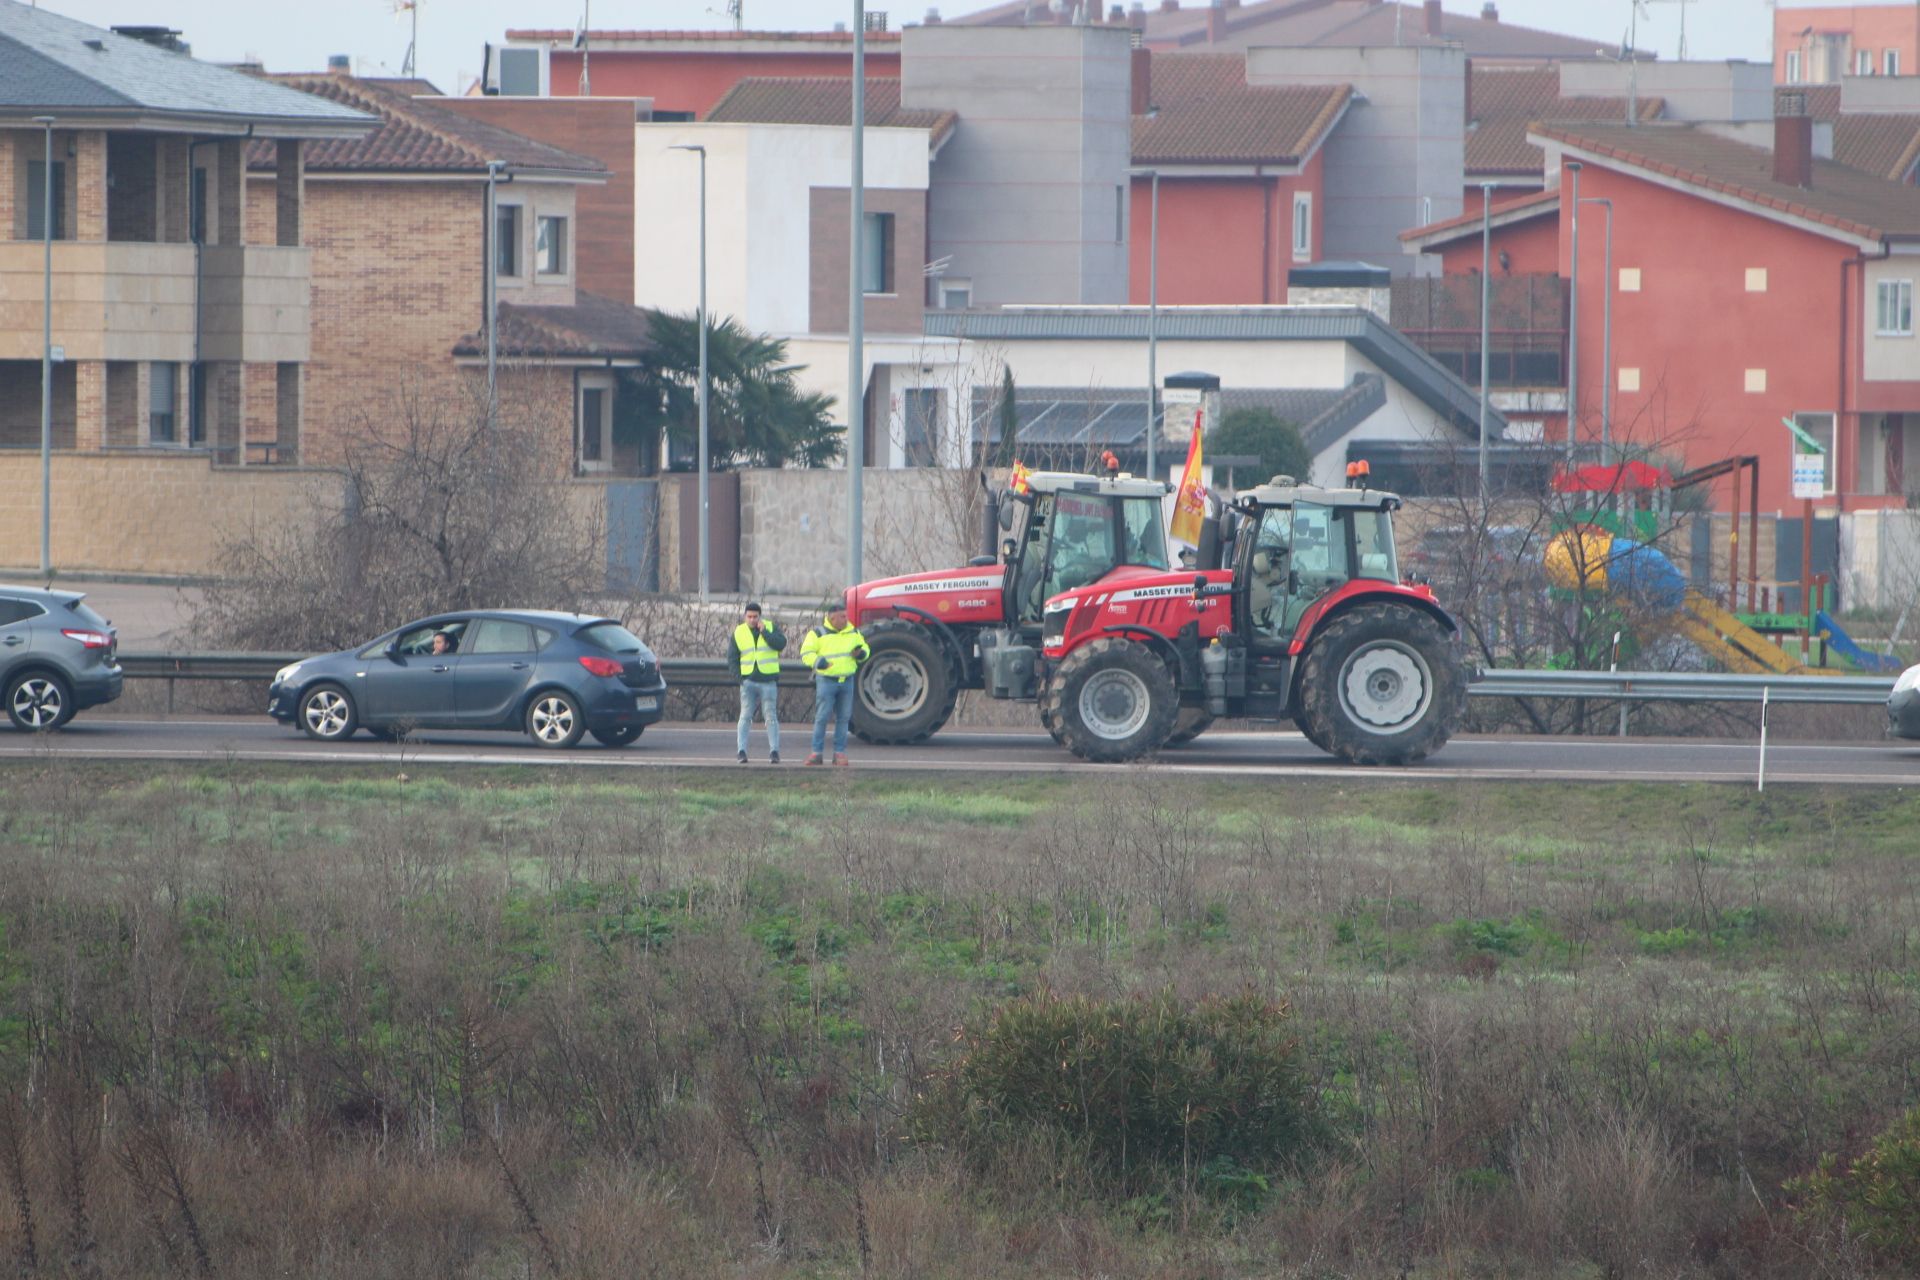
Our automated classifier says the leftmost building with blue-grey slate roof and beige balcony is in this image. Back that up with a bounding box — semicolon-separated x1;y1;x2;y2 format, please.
0;0;374;464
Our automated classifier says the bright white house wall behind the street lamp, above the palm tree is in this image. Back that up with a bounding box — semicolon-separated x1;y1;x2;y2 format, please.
634;125;927;336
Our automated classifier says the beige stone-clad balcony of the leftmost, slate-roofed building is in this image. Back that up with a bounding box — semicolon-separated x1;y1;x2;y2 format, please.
0;240;311;363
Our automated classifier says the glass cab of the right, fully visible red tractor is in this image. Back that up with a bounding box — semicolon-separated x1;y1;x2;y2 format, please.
1227;476;1400;651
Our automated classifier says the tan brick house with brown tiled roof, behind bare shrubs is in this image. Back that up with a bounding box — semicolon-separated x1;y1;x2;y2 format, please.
248;75;653;472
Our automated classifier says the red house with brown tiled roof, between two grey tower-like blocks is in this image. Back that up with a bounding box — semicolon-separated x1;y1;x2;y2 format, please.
1127;52;1354;305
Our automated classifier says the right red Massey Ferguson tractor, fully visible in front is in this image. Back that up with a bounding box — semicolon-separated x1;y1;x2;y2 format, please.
1029;476;1467;764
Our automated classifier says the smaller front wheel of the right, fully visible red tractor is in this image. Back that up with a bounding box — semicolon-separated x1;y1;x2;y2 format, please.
1041;637;1181;764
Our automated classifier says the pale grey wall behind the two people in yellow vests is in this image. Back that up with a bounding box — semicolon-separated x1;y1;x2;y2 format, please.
729;470;979;597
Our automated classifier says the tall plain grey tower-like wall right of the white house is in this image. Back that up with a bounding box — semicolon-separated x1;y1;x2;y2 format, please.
900;25;1133;307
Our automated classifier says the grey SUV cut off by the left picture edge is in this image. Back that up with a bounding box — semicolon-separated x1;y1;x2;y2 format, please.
0;583;121;733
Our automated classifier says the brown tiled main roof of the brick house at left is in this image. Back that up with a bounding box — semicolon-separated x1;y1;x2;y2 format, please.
248;75;607;175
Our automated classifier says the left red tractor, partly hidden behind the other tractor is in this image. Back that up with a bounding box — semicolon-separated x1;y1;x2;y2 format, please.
847;472;1169;745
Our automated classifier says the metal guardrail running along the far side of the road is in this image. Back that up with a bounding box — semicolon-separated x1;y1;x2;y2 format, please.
119;652;1893;706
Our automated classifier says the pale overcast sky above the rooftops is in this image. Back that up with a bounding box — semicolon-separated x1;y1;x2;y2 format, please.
40;0;1818;92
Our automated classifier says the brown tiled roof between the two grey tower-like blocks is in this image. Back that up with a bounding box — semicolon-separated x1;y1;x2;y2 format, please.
1133;54;1354;165
